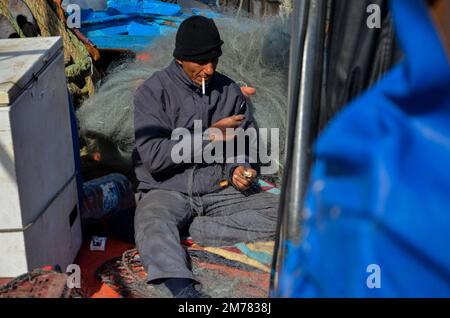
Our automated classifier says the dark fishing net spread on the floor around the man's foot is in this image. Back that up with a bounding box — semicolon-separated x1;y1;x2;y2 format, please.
96;246;270;298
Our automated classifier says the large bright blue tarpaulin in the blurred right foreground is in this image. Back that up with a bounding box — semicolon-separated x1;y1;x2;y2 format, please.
279;0;450;297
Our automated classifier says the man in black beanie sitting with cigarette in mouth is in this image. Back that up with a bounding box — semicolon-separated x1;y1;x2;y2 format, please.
134;16;278;298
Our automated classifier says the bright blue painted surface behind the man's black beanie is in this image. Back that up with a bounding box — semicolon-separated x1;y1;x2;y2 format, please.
81;0;223;52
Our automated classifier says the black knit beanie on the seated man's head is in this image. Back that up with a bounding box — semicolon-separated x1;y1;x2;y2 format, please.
173;15;223;61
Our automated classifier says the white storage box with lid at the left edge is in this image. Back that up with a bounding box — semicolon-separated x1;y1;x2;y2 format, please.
0;37;82;277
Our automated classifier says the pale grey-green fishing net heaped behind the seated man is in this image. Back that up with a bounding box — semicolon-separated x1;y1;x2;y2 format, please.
77;15;290;180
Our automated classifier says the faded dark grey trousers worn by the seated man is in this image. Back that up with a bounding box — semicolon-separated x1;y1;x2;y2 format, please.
134;187;278;283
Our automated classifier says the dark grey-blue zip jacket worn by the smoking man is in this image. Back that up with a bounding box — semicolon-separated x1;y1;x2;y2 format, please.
133;61;254;194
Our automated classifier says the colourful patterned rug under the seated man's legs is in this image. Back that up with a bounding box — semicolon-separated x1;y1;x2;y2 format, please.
92;180;280;298
